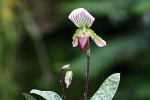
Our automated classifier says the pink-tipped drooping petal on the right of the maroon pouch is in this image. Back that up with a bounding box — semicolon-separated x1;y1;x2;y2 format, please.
90;34;106;47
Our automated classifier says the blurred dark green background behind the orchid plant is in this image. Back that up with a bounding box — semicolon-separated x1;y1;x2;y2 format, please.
0;0;150;100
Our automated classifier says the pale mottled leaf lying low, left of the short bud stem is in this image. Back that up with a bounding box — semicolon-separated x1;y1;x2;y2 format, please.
30;89;62;100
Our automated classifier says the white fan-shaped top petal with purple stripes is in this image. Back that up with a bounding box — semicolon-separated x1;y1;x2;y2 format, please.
68;8;95;27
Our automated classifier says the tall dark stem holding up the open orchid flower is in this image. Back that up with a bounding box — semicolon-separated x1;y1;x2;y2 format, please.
84;47;90;100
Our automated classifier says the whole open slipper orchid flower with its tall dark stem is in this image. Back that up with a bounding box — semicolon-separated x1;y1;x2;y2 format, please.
68;8;106;100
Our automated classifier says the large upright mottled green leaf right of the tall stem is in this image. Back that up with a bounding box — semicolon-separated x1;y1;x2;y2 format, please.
90;73;120;100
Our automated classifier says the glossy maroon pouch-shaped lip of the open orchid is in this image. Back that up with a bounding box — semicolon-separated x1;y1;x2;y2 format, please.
78;36;90;51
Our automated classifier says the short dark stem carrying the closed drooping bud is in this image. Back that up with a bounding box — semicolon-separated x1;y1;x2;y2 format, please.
60;69;66;100
